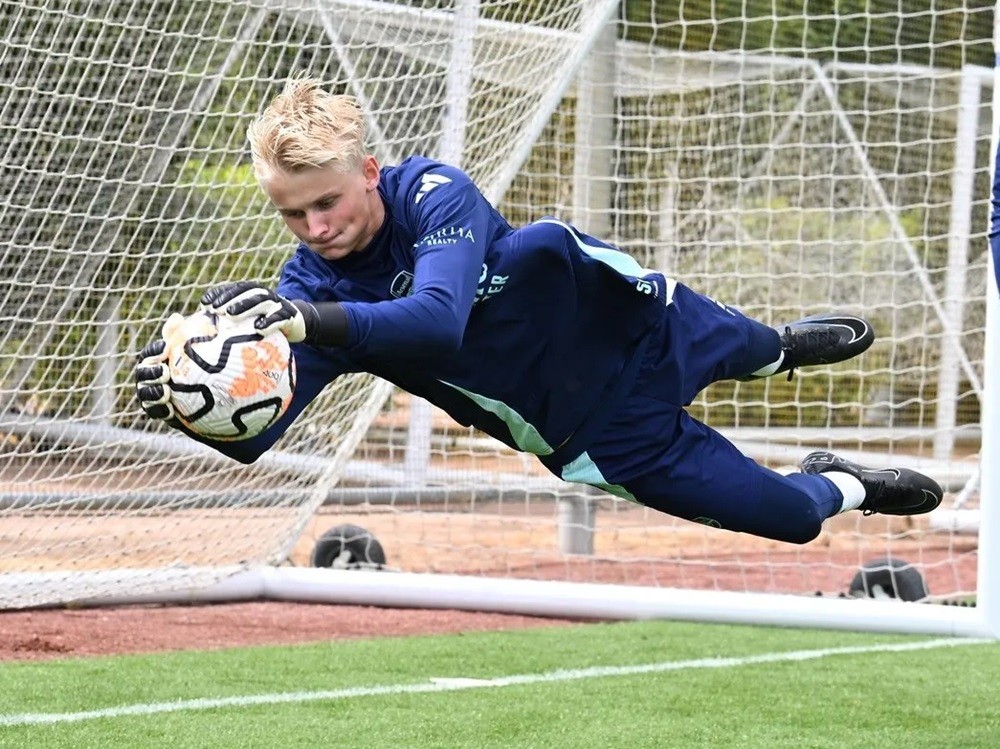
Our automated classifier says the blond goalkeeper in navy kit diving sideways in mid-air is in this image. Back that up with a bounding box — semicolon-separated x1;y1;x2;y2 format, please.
135;79;942;544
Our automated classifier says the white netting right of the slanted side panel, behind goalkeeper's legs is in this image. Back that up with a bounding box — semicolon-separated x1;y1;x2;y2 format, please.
297;4;992;598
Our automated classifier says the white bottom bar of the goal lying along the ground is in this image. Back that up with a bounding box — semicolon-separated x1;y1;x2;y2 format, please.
0;567;1000;638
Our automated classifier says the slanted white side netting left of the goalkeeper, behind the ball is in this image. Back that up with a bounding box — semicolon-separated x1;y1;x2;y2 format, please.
0;0;610;607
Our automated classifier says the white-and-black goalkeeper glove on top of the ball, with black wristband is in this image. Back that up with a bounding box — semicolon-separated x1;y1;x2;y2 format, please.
201;281;348;346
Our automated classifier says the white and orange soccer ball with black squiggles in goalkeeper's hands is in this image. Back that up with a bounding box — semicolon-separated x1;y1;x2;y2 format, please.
164;311;295;441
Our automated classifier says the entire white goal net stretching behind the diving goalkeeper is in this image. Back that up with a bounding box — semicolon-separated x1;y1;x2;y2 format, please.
0;0;992;636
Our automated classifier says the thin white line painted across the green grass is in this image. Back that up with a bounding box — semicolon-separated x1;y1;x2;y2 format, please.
0;638;996;726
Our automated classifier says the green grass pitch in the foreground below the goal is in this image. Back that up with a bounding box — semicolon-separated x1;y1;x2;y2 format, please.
0;622;1000;749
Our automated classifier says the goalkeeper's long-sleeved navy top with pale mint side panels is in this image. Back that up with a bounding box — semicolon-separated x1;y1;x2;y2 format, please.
209;156;672;462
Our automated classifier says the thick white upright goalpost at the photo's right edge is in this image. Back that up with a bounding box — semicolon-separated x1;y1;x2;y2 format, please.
976;2;1000;637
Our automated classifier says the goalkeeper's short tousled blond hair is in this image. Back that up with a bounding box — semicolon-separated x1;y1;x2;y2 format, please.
247;78;367;182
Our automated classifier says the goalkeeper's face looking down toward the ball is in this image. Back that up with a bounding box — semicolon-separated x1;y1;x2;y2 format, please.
264;156;385;260
